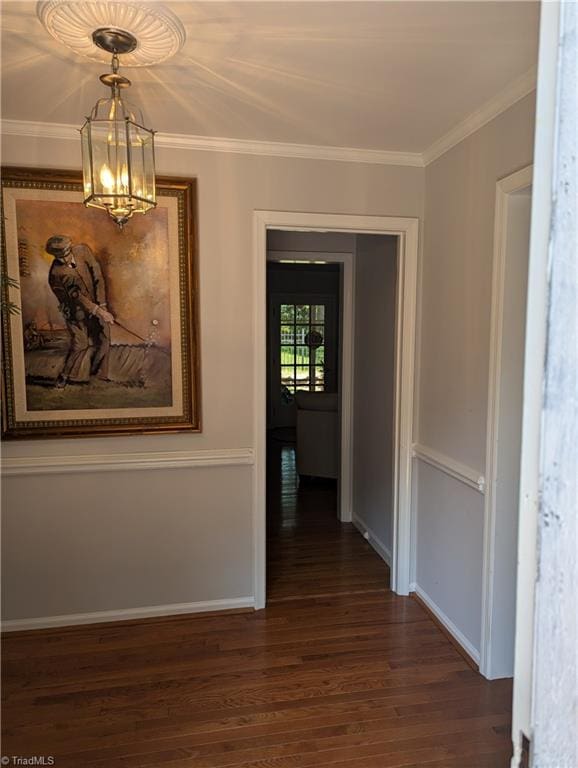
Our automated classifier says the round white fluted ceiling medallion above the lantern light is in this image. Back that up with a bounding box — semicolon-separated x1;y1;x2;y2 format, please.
37;0;186;67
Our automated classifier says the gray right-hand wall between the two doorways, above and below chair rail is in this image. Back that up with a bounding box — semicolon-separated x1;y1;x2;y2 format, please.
414;94;535;650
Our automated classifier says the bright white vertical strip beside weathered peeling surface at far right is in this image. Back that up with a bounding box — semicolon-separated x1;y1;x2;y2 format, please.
511;2;562;768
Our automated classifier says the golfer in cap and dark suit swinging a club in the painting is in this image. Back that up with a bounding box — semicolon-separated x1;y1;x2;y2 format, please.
45;235;114;388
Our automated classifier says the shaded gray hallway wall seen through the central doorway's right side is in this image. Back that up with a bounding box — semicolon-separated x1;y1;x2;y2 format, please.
353;235;397;560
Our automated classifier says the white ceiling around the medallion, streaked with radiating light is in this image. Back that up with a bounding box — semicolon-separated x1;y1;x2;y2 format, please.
1;0;539;152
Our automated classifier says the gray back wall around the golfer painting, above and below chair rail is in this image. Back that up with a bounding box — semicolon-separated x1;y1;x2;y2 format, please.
2;129;423;619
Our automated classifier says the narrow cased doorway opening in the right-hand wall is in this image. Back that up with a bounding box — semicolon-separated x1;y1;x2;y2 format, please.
480;167;532;679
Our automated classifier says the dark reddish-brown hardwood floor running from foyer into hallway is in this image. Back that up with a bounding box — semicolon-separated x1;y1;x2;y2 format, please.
2;444;511;768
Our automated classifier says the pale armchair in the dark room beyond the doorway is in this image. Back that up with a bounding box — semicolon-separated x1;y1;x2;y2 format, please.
295;392;339;478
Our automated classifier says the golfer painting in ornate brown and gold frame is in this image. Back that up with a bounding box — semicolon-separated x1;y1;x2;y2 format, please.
1;168;200;438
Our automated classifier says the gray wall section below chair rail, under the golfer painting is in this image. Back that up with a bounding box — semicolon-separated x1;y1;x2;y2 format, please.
2;466;253;619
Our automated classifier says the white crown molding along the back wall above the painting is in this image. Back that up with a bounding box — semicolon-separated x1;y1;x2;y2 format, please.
1;120;423;168
